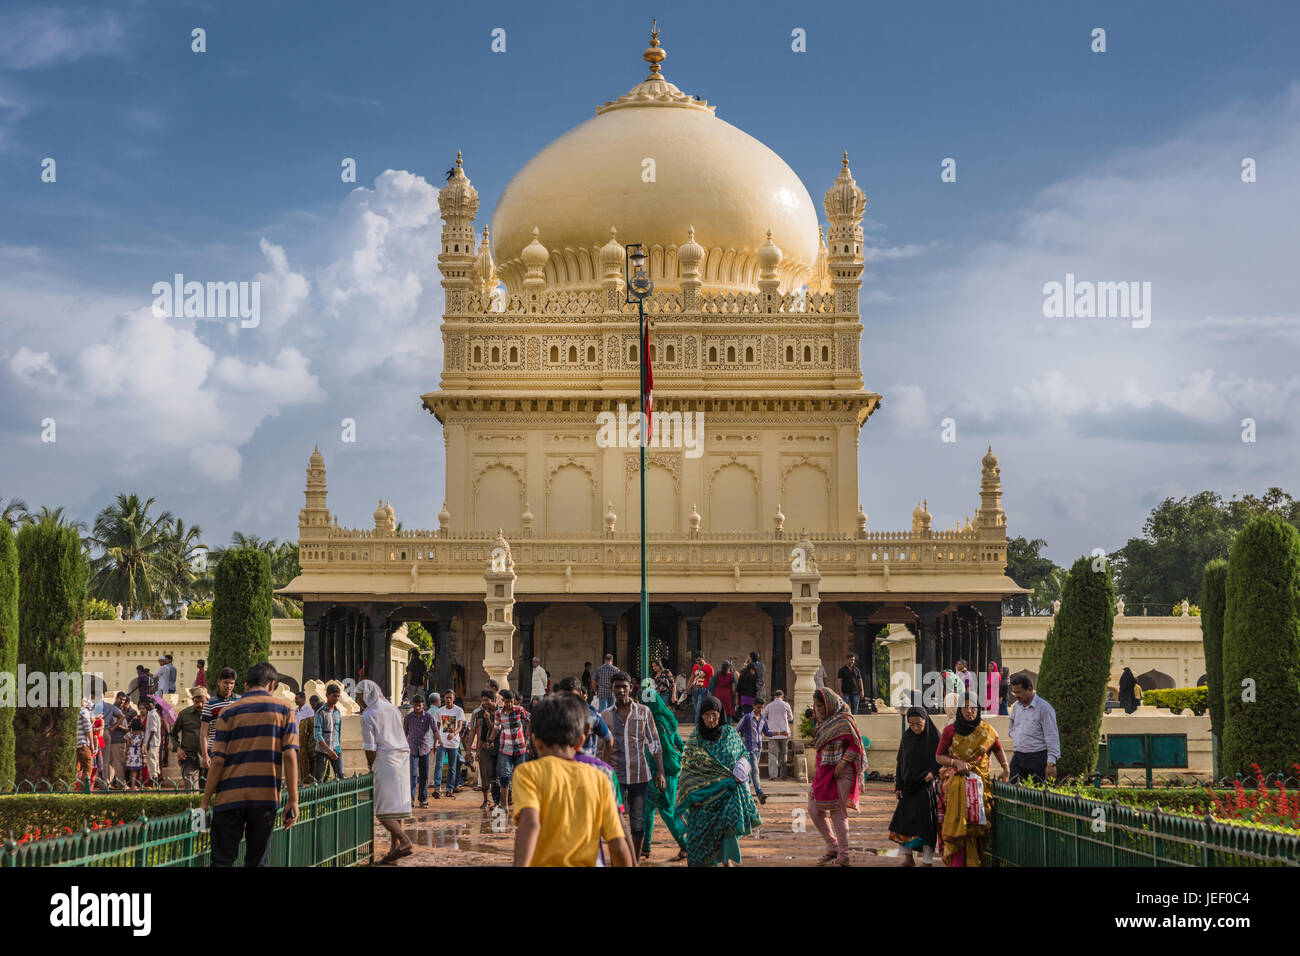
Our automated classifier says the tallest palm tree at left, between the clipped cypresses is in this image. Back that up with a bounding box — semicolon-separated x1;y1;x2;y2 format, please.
90;494;173;617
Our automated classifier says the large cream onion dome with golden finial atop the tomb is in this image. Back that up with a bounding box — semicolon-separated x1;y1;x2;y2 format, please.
491;51;818;291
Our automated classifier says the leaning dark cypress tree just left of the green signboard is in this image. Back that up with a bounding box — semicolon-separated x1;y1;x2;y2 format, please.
1037;557;1115;777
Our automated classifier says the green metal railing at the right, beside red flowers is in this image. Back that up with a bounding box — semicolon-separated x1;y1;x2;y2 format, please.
984;780;1300;866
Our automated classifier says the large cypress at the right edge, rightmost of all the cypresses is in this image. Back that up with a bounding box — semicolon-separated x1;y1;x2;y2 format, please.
1221;515;1300;774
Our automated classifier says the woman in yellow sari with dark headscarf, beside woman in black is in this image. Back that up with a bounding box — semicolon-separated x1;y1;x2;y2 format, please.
935;693;1011;866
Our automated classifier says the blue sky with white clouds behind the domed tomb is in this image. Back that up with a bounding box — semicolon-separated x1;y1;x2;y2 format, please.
0;1;1300;564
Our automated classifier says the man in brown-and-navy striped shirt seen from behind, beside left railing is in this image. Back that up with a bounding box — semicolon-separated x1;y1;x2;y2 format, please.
200;663;298;866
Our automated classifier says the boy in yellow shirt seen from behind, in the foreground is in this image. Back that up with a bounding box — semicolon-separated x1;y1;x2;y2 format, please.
511;693;636;866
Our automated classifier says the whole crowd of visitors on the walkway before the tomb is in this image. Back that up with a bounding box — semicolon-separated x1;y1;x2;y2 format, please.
78;653;1060;866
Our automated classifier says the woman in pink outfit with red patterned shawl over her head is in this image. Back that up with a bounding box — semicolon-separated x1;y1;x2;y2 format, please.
809;687;867;866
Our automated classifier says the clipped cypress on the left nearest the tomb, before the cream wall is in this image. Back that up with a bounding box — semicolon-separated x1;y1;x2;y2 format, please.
208;548;272;693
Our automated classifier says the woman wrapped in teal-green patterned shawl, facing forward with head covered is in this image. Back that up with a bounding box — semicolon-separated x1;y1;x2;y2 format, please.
677;697;762;866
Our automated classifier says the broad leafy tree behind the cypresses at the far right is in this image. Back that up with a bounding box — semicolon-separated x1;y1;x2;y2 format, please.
1112;488;1300;614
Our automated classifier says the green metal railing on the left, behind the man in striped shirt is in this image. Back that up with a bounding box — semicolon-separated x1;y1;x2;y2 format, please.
0;774;374;868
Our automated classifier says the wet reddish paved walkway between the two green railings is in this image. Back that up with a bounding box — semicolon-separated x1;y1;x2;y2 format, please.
374;780;901;866
